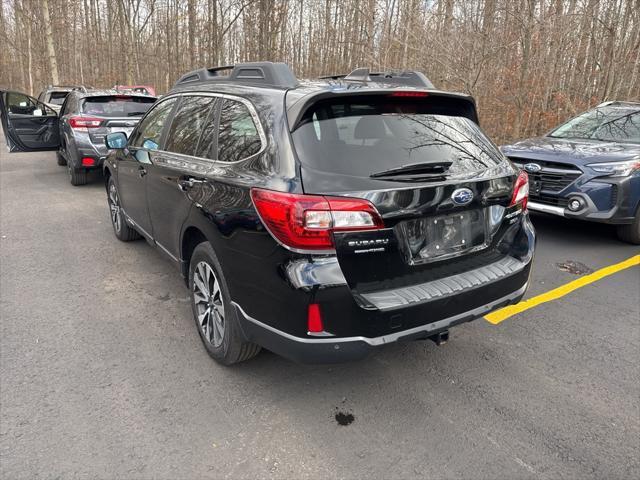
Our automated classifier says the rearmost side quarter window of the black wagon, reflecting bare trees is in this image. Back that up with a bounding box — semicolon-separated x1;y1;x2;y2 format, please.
218;99;262;162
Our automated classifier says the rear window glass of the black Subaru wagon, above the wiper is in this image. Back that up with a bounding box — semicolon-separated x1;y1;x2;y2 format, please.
293;96;503;177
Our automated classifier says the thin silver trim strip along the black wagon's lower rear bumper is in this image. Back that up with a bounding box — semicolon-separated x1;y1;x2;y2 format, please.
231;282;529;347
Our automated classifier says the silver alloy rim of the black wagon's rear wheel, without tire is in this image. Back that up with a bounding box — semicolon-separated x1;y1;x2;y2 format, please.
193;262;225;347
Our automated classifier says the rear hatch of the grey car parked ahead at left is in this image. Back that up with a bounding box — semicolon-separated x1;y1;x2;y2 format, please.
82;95;155;145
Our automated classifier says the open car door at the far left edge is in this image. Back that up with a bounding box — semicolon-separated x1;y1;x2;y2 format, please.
0;90;60;152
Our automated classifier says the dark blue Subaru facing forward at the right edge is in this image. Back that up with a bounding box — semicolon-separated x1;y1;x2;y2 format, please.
502;102;640;244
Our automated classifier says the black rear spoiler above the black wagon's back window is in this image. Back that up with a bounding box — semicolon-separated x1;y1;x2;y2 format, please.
287;88;480;131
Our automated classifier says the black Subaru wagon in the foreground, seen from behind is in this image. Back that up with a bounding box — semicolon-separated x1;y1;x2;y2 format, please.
104;62;535;364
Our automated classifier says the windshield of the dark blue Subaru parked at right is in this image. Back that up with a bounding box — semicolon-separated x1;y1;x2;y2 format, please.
549;108;640;143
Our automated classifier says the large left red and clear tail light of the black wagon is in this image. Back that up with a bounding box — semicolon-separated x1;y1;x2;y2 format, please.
251;188;384;251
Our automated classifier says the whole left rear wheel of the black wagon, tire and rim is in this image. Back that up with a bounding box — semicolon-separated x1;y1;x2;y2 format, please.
189;242;261;365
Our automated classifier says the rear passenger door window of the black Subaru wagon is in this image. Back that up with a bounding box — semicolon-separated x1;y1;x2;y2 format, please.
164;96;215;155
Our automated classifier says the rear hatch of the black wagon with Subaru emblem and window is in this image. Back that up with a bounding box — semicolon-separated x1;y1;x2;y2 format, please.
292;91;526;310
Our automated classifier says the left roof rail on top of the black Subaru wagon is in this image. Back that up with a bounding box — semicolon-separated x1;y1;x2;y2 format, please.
173;62;298;88
